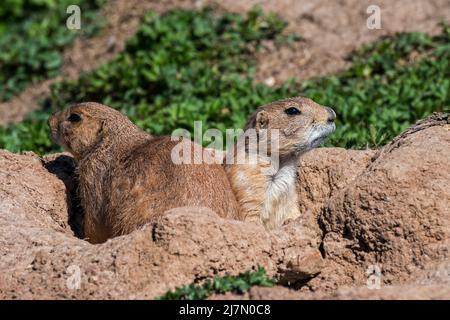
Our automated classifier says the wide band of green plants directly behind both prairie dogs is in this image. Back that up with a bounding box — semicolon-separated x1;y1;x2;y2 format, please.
0;10;450;153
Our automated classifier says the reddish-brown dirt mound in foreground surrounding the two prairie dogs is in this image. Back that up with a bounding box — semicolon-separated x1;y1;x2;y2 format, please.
0;114;450;299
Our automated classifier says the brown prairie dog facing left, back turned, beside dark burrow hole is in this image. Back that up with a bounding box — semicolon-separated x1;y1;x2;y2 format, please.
48;102;238;243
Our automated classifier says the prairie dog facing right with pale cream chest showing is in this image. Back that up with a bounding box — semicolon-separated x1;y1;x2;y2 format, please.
225;97;336;229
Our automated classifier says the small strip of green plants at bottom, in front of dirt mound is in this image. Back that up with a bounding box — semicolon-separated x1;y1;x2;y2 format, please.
159;267;276;300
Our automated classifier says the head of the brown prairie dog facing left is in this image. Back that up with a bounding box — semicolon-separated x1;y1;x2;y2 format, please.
48;102;135;160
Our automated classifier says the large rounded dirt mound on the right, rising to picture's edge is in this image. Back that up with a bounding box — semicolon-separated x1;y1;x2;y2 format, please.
314;114;450;288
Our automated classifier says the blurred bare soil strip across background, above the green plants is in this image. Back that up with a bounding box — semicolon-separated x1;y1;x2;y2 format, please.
0;0;450;124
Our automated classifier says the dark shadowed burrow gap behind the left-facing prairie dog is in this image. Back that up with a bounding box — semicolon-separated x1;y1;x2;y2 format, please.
44;155;84;239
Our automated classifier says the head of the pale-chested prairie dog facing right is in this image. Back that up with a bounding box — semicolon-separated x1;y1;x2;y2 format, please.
246;97;336;158
